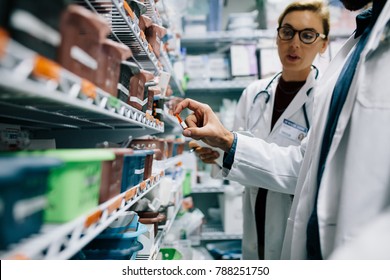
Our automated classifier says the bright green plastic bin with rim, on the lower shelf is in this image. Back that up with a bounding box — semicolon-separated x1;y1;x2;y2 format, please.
33;149;115;223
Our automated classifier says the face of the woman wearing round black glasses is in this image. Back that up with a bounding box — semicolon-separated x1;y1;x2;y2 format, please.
277;11;328;81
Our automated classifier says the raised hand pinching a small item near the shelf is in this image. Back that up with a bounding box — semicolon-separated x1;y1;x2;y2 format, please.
174;98;234;152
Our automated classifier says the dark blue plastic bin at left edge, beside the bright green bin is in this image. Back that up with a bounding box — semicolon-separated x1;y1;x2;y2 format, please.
0;157;61;249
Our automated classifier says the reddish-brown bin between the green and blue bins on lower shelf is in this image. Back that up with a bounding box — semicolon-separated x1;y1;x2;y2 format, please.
99;148;133;203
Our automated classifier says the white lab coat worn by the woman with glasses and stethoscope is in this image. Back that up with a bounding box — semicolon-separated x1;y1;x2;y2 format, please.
224;69;318;259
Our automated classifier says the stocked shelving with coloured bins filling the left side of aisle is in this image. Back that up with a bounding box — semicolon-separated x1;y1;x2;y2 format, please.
0;0;189;260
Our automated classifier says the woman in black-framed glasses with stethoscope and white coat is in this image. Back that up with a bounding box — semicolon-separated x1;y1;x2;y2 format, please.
190;1;329;259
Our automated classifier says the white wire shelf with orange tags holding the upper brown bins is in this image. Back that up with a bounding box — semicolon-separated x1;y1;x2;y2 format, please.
0;33;164;147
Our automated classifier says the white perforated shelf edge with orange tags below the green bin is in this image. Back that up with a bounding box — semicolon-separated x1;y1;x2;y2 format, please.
0;168;164;260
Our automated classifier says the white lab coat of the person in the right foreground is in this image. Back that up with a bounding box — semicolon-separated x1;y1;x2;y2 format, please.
227;2;390;259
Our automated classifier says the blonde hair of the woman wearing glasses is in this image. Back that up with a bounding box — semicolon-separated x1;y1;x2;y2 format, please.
278;0;330;38
